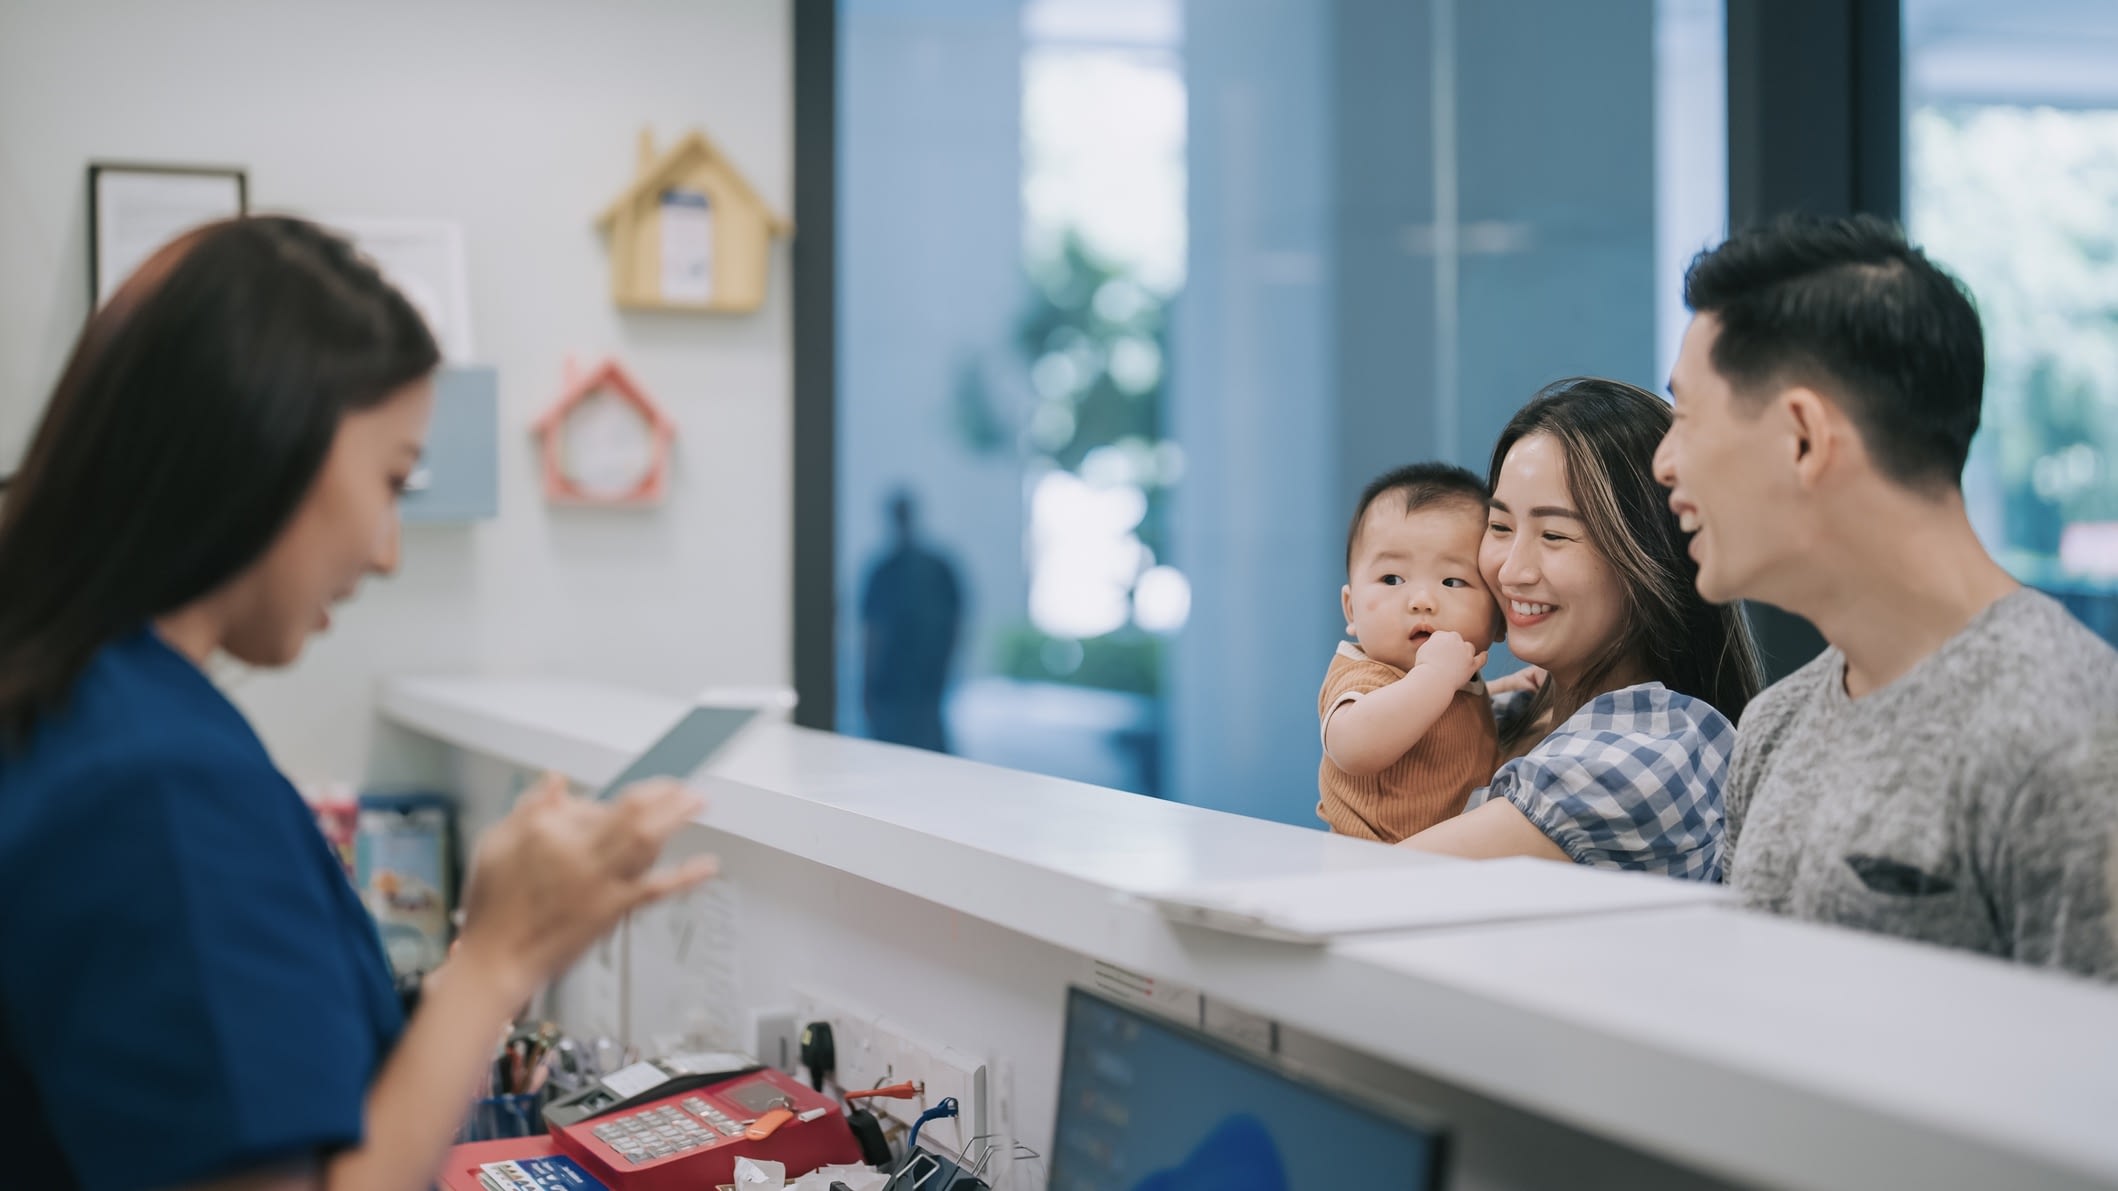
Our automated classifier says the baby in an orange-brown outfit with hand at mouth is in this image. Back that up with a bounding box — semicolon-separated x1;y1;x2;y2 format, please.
1317;464;1504;843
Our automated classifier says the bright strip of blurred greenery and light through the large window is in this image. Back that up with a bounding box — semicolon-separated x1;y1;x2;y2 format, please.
995;40;1190;697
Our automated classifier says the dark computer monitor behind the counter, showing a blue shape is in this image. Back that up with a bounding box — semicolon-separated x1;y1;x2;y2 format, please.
1051;988;1447;1191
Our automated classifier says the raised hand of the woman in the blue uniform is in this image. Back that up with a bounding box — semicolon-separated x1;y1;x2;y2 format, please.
460;774;718;1000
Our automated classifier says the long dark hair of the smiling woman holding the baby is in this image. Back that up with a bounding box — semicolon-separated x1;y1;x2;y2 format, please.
1489;377;1760;744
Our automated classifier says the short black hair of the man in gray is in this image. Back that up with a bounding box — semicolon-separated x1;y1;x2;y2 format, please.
1684;216;1985;487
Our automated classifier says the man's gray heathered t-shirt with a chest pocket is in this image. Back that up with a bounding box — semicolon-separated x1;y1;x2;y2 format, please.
1724;589;2118;981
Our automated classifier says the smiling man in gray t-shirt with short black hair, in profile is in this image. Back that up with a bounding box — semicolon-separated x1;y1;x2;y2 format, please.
1654;218;2118;981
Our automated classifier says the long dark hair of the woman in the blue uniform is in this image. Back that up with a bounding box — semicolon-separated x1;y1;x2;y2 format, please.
0;216;441;740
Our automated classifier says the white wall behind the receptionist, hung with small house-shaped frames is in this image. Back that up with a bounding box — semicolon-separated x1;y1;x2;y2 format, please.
0;0;792;780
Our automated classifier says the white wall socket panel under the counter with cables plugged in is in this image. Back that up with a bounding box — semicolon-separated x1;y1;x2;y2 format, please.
796;985;995;1155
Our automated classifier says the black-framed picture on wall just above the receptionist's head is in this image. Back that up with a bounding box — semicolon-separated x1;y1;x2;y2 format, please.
89;161;250;307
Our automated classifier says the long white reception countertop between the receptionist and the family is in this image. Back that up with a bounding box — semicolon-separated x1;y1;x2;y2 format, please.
381;678;2118;1187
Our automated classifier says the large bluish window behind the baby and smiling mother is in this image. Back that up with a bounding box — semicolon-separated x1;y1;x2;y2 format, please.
837;0;1726;822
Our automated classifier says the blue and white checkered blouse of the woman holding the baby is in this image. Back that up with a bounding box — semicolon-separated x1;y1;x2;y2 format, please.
1466;682;1735;882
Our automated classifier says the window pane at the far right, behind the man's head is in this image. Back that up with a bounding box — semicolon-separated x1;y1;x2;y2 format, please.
1904;0;2118;638
